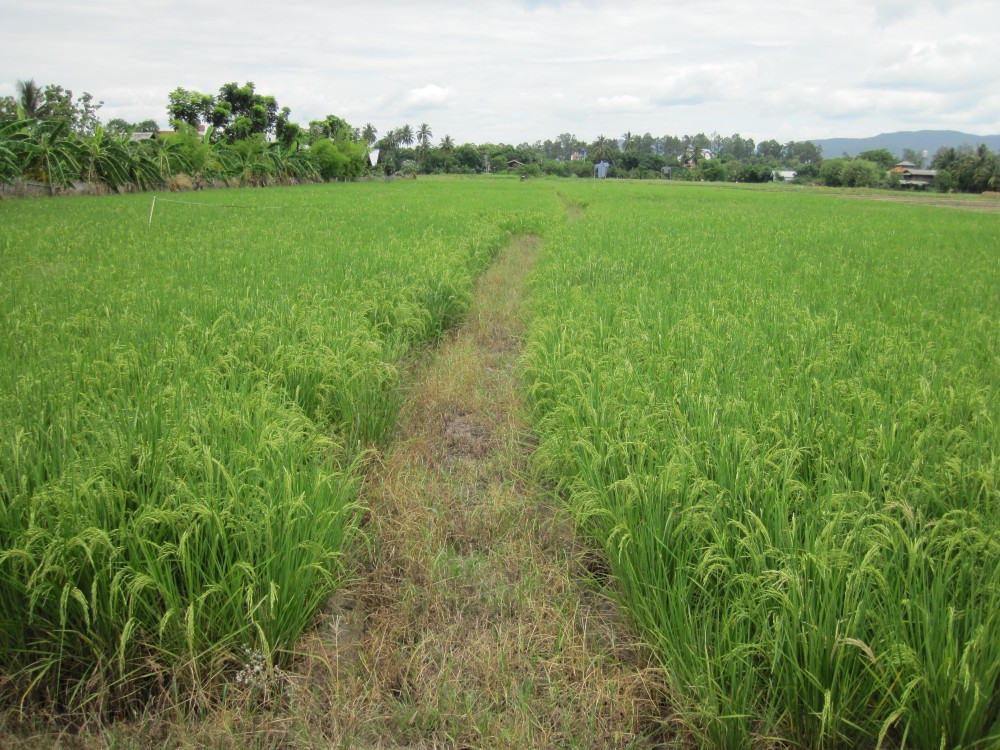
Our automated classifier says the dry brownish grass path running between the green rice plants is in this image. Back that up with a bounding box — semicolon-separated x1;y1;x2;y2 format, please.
301;237;658;748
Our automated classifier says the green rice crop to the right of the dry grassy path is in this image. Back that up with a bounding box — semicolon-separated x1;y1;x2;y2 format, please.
525;184;1000;748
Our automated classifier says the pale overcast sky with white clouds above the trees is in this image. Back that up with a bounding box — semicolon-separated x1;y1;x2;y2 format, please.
0;0;1000;143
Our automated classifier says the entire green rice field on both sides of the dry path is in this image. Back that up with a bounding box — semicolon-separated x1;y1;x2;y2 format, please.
0;179;1000;748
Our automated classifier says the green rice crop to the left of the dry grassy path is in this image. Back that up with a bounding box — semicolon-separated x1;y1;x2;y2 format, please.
0;182;557;710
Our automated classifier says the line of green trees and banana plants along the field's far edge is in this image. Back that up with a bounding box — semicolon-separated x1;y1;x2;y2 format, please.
0;80;1000;194
